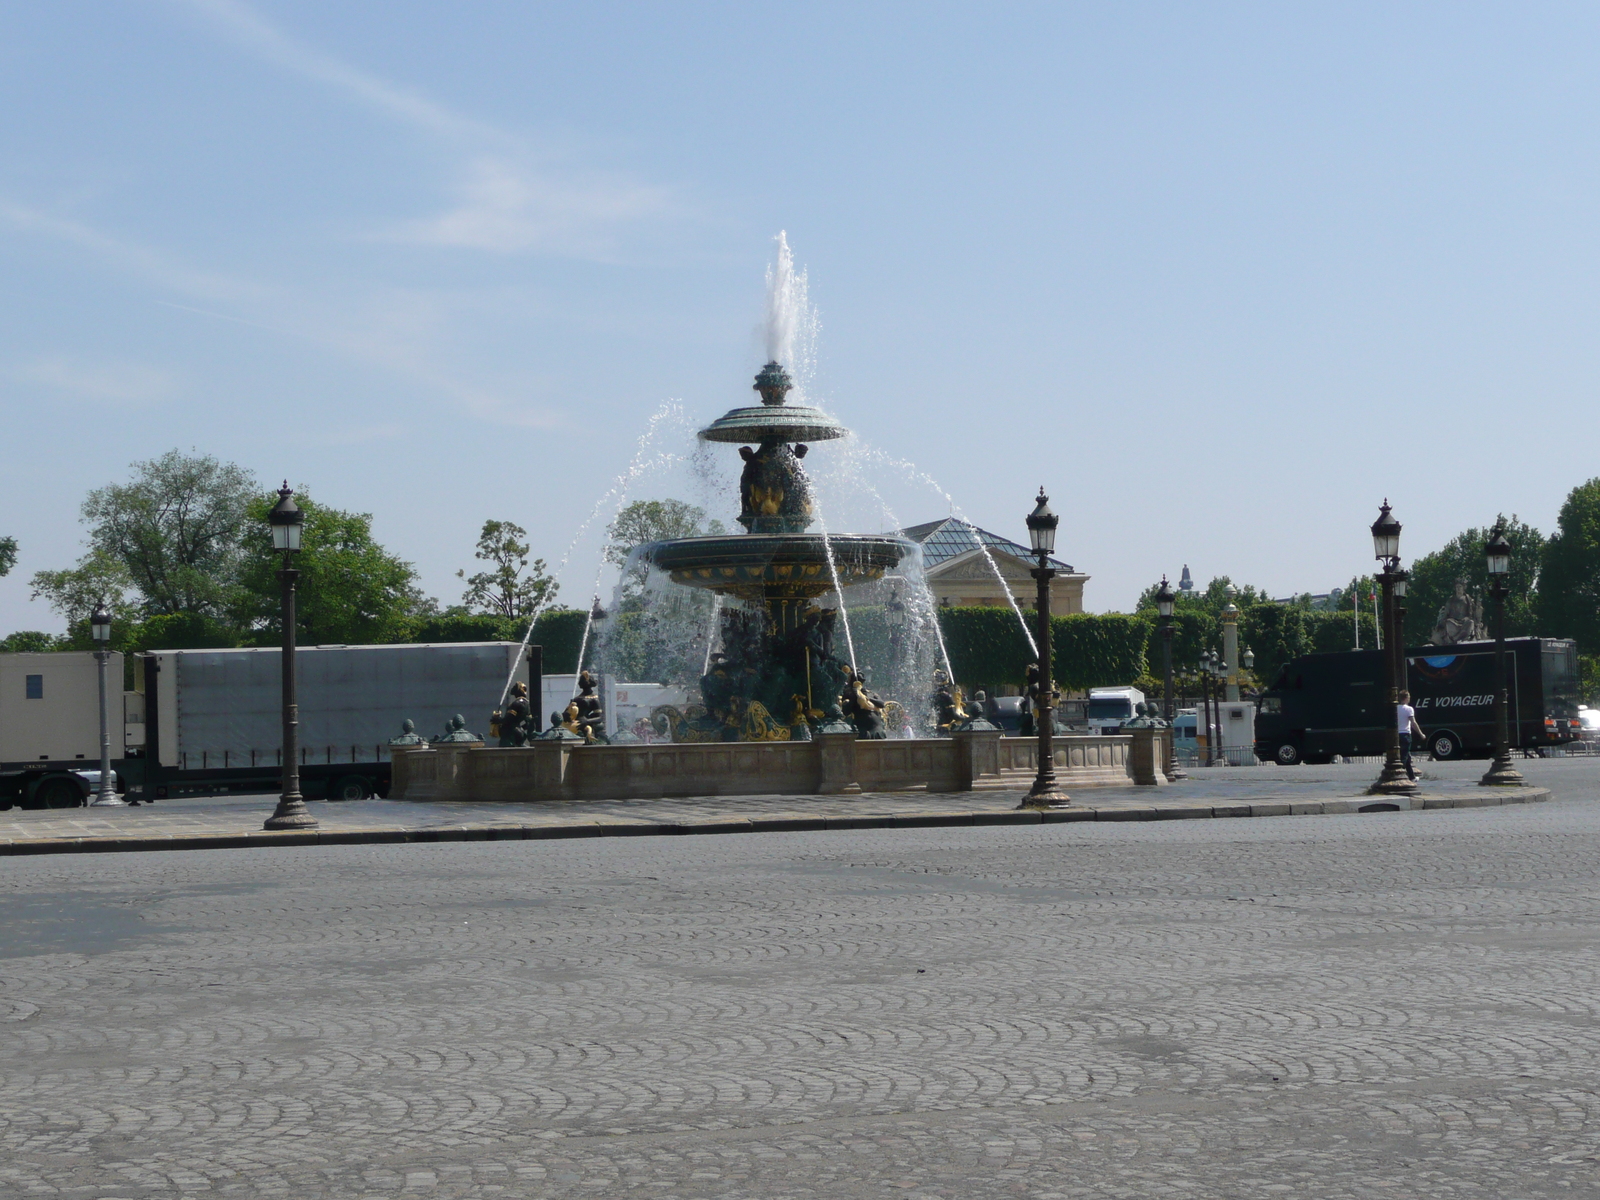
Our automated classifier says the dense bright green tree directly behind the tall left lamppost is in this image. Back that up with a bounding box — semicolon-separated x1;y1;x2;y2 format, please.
232;493;437;645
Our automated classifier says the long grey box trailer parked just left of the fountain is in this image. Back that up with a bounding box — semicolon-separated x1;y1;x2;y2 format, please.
130;642;528;800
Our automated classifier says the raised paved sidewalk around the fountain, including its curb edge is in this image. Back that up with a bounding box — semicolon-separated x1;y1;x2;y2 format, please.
0;765;1548;856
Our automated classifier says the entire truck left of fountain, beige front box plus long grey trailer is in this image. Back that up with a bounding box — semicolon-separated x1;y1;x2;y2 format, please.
0;642;542;808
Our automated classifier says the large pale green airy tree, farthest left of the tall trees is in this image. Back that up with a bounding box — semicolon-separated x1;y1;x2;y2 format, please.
77;450;259;616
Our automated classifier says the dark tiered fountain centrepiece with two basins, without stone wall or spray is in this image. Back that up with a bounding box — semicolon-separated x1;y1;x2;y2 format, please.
642;362;915;742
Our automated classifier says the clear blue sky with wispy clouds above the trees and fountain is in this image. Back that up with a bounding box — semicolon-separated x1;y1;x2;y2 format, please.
0;0;1600;632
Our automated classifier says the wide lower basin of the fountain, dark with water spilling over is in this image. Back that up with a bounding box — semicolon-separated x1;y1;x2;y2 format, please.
646;533;915;600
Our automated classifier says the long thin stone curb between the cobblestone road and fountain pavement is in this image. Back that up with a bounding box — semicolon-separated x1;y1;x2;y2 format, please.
0;787;1550;856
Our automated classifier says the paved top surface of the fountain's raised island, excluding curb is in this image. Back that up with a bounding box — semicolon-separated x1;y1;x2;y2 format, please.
0;758;1580;853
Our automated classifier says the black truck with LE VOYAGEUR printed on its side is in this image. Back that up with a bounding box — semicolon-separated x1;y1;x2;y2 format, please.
1256;637;1581;766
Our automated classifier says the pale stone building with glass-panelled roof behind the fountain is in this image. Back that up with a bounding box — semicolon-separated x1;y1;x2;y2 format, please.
901;517;1088;614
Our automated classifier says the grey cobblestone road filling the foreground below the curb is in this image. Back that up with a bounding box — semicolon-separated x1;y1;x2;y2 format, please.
0;768;1600;1200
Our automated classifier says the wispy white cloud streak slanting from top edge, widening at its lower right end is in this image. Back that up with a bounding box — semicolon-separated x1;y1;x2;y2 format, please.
172;0;682;258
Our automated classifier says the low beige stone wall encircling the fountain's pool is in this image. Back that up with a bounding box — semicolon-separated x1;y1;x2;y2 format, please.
389;731;1165;803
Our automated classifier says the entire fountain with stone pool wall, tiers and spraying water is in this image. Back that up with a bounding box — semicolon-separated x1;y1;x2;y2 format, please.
390;237;1164;802
